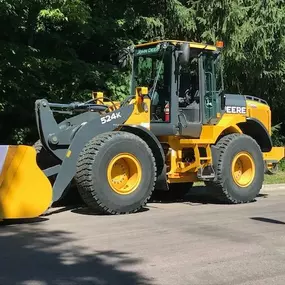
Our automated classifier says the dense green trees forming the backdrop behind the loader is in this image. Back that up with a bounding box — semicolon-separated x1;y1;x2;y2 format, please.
0;0;285;145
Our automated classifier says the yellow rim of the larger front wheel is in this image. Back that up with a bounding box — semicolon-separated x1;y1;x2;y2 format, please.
107;153;142;195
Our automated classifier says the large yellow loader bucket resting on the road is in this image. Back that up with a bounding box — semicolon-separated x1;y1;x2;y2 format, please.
0;145;52;220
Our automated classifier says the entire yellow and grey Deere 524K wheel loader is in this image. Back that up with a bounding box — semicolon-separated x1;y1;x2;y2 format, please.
0;40;284;220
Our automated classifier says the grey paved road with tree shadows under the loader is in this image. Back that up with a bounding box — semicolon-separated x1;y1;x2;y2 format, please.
0;184;285;285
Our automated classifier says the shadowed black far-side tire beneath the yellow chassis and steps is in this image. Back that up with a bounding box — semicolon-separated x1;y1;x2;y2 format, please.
152;182;194;202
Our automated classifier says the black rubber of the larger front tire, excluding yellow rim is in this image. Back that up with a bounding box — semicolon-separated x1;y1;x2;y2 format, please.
75;132;156;214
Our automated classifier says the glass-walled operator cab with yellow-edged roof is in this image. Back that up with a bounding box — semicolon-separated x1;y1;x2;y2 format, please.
129;41;223;138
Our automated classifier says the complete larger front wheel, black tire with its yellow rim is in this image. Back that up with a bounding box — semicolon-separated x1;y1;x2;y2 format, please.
75;132;156;214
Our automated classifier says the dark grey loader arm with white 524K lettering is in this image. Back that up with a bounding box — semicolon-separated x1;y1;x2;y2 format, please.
36;99;134;201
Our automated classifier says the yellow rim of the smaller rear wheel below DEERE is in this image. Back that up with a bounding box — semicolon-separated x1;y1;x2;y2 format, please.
232;152;255;188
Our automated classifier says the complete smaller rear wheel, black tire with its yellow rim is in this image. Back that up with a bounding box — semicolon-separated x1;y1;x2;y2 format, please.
205;134;264;204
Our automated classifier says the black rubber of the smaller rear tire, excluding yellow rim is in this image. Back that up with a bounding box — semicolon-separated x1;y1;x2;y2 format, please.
205;134;264;204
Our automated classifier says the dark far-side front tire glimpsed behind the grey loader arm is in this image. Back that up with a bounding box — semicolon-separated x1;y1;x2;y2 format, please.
33;140;83;207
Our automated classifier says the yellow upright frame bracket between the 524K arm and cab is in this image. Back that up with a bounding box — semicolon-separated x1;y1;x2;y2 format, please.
125;87;151;129
